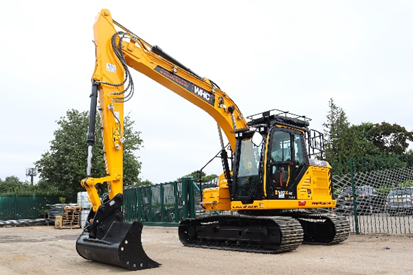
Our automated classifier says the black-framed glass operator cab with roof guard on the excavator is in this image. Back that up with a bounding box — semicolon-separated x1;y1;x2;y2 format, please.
230;110;323;204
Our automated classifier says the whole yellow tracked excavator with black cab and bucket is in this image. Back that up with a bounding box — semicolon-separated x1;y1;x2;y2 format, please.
76;9;349;270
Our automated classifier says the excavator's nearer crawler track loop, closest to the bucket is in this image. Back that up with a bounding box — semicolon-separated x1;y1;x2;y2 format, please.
179;216;304;254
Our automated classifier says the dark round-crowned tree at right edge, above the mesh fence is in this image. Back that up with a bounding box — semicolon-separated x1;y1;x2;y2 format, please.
369;122;413;154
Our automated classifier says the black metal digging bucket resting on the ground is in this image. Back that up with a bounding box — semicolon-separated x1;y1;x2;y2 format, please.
76;195;160;270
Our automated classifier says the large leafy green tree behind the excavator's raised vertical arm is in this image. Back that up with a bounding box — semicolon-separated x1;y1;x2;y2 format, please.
35;109;142;195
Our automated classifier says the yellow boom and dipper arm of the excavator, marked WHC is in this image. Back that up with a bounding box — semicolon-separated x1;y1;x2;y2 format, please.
81;9;248;211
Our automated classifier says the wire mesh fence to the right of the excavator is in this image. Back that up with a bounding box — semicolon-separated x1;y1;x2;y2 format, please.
332;155;413;234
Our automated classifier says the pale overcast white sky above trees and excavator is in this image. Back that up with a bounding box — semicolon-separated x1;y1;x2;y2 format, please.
0;0;413;183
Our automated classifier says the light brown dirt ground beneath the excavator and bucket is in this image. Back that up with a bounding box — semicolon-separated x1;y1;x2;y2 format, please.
0;226;413;275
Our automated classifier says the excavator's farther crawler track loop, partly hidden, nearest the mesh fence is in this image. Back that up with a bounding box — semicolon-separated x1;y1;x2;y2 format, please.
291;212;350;245
